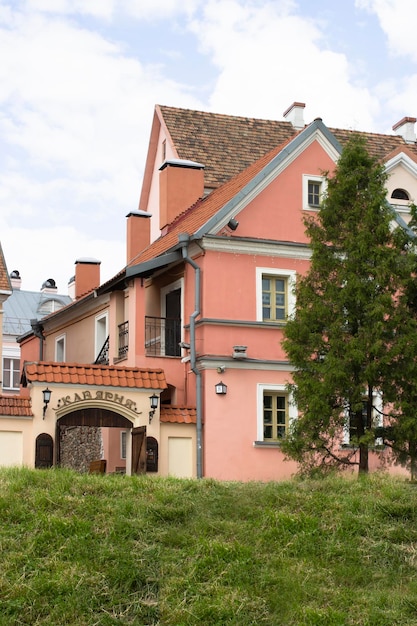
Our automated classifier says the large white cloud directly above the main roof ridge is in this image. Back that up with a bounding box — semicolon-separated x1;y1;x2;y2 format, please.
192;0;378;130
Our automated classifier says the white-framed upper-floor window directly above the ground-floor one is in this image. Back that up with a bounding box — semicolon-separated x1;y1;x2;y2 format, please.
256;267;296;324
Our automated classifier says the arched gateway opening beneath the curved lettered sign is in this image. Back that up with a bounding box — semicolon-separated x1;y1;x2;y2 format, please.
56;407;136;473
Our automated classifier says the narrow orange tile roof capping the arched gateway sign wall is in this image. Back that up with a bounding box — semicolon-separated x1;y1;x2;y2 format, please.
22;361;167;389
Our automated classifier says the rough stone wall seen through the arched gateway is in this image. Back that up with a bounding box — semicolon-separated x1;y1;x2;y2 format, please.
60;426;103;472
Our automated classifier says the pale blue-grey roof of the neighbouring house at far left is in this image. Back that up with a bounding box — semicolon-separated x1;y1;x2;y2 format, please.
3;289;72;337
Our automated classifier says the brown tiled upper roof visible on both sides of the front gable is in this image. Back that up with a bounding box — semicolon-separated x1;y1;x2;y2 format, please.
140;105;417;202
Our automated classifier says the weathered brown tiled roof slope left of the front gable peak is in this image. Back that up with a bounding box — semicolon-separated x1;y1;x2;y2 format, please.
158;105;297;188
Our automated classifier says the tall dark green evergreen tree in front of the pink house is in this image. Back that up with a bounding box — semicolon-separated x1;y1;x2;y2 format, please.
283;136;417;472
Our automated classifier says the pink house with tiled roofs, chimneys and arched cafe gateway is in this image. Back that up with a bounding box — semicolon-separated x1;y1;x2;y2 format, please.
0;103;417;481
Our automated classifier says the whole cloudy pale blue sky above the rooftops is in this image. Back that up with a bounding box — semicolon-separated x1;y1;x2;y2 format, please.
0;0;417;294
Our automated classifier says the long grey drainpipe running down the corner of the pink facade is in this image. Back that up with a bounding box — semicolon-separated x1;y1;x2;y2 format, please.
178;233;203;478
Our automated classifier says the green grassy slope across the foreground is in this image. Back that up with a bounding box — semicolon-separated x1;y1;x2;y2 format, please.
0;469;417;626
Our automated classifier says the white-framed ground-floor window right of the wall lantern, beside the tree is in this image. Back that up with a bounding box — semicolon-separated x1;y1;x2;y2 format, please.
255;383;297;445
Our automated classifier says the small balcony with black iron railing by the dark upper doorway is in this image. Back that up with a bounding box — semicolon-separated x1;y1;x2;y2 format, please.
145;316;181;356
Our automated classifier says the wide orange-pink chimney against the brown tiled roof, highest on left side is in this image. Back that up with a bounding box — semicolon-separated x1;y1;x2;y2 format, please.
159;159;204;230
